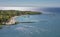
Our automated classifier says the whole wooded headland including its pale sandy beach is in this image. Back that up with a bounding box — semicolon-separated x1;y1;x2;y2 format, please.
0;10;42;25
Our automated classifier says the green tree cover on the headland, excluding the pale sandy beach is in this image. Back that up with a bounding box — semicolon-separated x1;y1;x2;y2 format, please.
0;10;41;25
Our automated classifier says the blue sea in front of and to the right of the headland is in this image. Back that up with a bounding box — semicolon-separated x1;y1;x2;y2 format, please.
0;8;60;37
